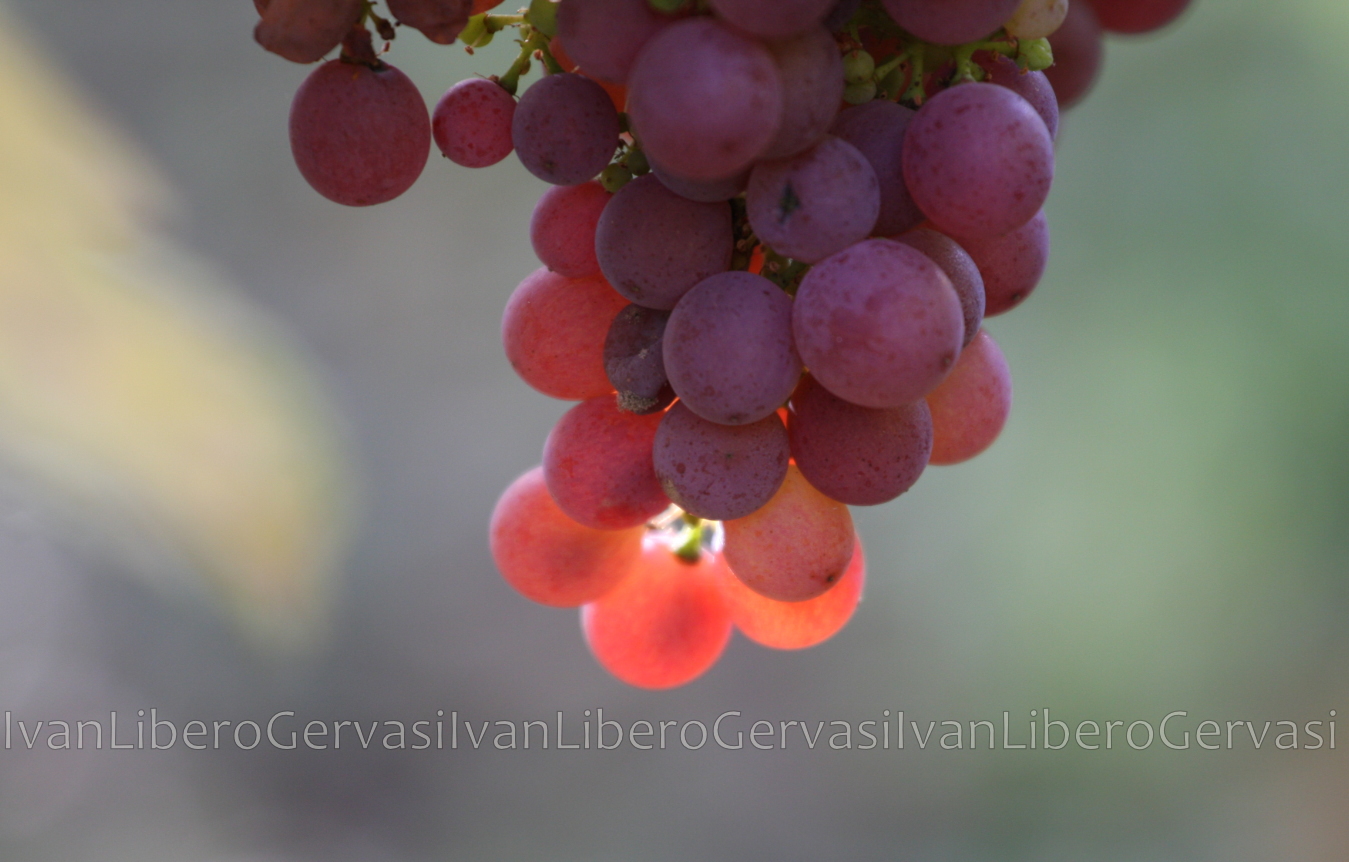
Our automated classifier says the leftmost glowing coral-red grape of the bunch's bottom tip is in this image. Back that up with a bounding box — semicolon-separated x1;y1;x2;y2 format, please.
488;467;646;607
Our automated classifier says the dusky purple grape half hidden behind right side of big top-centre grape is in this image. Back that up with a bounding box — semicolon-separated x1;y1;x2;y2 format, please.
759;27;843;159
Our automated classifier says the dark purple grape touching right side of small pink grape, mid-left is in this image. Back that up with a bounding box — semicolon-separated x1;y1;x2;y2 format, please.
595;174;735;310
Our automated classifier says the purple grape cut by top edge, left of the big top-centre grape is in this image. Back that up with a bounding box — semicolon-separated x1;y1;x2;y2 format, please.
557;0;669;84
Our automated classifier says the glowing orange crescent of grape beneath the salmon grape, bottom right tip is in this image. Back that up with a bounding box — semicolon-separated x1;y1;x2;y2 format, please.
722;538;866;649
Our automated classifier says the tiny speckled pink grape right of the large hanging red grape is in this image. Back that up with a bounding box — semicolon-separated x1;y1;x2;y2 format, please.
430;78;515;167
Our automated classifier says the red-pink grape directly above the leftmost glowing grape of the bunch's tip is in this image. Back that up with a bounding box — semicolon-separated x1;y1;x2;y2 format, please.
544;395;669;530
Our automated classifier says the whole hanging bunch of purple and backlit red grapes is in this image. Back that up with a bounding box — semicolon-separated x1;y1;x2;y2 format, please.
255;0;1187;688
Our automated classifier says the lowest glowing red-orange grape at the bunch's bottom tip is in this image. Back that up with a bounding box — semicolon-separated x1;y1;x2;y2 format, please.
581;540;731;688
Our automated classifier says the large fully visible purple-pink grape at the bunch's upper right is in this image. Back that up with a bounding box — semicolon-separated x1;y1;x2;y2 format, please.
904;84;1054;237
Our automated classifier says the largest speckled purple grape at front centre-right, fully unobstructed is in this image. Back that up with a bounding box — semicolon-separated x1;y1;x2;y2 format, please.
793;239;965;407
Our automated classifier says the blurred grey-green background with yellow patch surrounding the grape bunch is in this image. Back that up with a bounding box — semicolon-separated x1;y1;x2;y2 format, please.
0;0;1349;862
